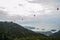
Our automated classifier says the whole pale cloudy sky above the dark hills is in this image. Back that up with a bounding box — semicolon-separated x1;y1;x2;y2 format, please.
0;0;60;31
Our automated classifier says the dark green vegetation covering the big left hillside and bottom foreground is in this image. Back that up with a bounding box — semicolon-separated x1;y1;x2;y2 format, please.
0;22;60;40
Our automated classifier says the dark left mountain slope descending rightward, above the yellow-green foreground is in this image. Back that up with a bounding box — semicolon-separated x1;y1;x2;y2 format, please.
0;22;47;40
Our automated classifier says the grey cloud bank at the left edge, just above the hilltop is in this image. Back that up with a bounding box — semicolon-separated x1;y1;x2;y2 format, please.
0;10;22;21
